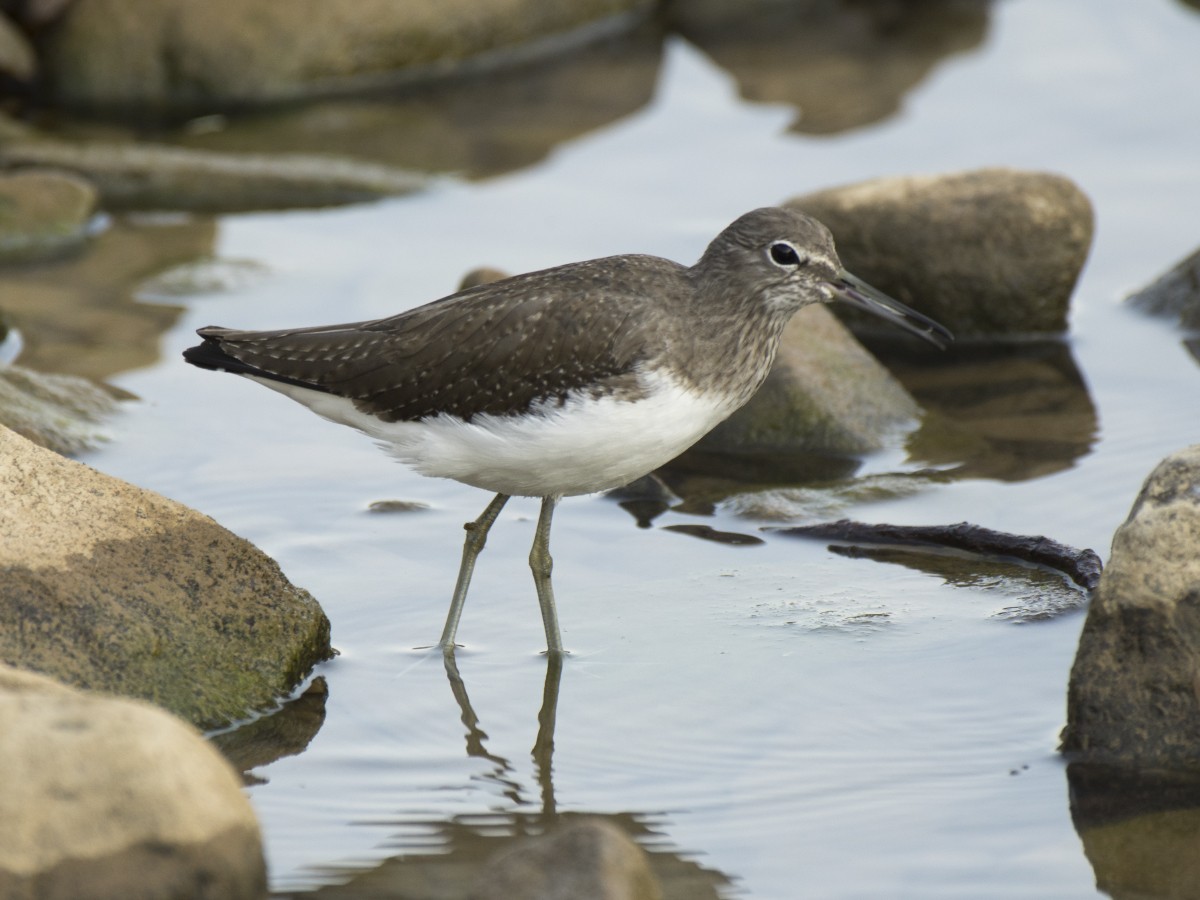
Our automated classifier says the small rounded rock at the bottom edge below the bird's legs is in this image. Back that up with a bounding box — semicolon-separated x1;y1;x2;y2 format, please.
470;820;662;900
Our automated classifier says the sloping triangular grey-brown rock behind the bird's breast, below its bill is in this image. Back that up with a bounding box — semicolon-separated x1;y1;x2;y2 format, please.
697;306;920;455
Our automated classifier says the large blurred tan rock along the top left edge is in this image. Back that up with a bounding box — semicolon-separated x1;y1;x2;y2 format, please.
43;0;650;115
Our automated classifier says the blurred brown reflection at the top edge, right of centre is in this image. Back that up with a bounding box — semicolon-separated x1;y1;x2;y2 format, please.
667;0;988;134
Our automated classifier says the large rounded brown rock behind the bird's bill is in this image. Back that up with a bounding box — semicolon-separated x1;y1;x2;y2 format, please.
785;169;1093;337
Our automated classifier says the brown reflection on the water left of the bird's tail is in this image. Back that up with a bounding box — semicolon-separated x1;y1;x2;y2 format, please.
0;220;216;380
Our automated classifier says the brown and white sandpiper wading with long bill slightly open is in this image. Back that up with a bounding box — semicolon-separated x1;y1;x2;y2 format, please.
184;208;952;653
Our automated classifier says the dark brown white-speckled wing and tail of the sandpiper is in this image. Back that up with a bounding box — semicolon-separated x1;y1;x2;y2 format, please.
184;257;686;422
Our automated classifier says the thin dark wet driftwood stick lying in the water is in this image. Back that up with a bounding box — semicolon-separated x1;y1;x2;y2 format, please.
779;518;1103;590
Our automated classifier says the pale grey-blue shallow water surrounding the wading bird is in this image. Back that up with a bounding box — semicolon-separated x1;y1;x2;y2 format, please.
51;0;1200;898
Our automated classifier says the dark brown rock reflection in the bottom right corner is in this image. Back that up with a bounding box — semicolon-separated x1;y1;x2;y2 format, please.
1067;763;1200;900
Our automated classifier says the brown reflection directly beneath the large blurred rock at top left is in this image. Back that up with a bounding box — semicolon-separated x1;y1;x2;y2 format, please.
172;26;661;178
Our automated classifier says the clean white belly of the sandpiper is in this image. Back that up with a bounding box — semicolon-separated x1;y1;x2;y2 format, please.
251;373;733;497
